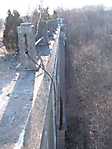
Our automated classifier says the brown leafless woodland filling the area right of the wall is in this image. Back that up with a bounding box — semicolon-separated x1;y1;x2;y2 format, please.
63;7;112;149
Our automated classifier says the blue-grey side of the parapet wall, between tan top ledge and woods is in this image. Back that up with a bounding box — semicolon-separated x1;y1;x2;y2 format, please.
41;29;65;149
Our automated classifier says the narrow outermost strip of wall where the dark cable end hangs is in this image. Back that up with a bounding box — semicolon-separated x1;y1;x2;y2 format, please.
57;31;66;149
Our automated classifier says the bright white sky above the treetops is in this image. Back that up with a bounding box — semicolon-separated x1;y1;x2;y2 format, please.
0;0;112;18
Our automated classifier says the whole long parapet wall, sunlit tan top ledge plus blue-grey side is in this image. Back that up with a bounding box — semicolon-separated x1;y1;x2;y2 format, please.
18;27;65;149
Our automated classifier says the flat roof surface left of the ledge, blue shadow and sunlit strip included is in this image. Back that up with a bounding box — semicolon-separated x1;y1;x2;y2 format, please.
0;55;35;149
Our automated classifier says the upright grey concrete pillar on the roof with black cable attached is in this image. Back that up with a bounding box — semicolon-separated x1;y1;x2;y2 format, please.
18;23;37;70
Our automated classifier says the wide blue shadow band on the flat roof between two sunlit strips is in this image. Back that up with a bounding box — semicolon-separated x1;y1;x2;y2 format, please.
0;71;35;146
